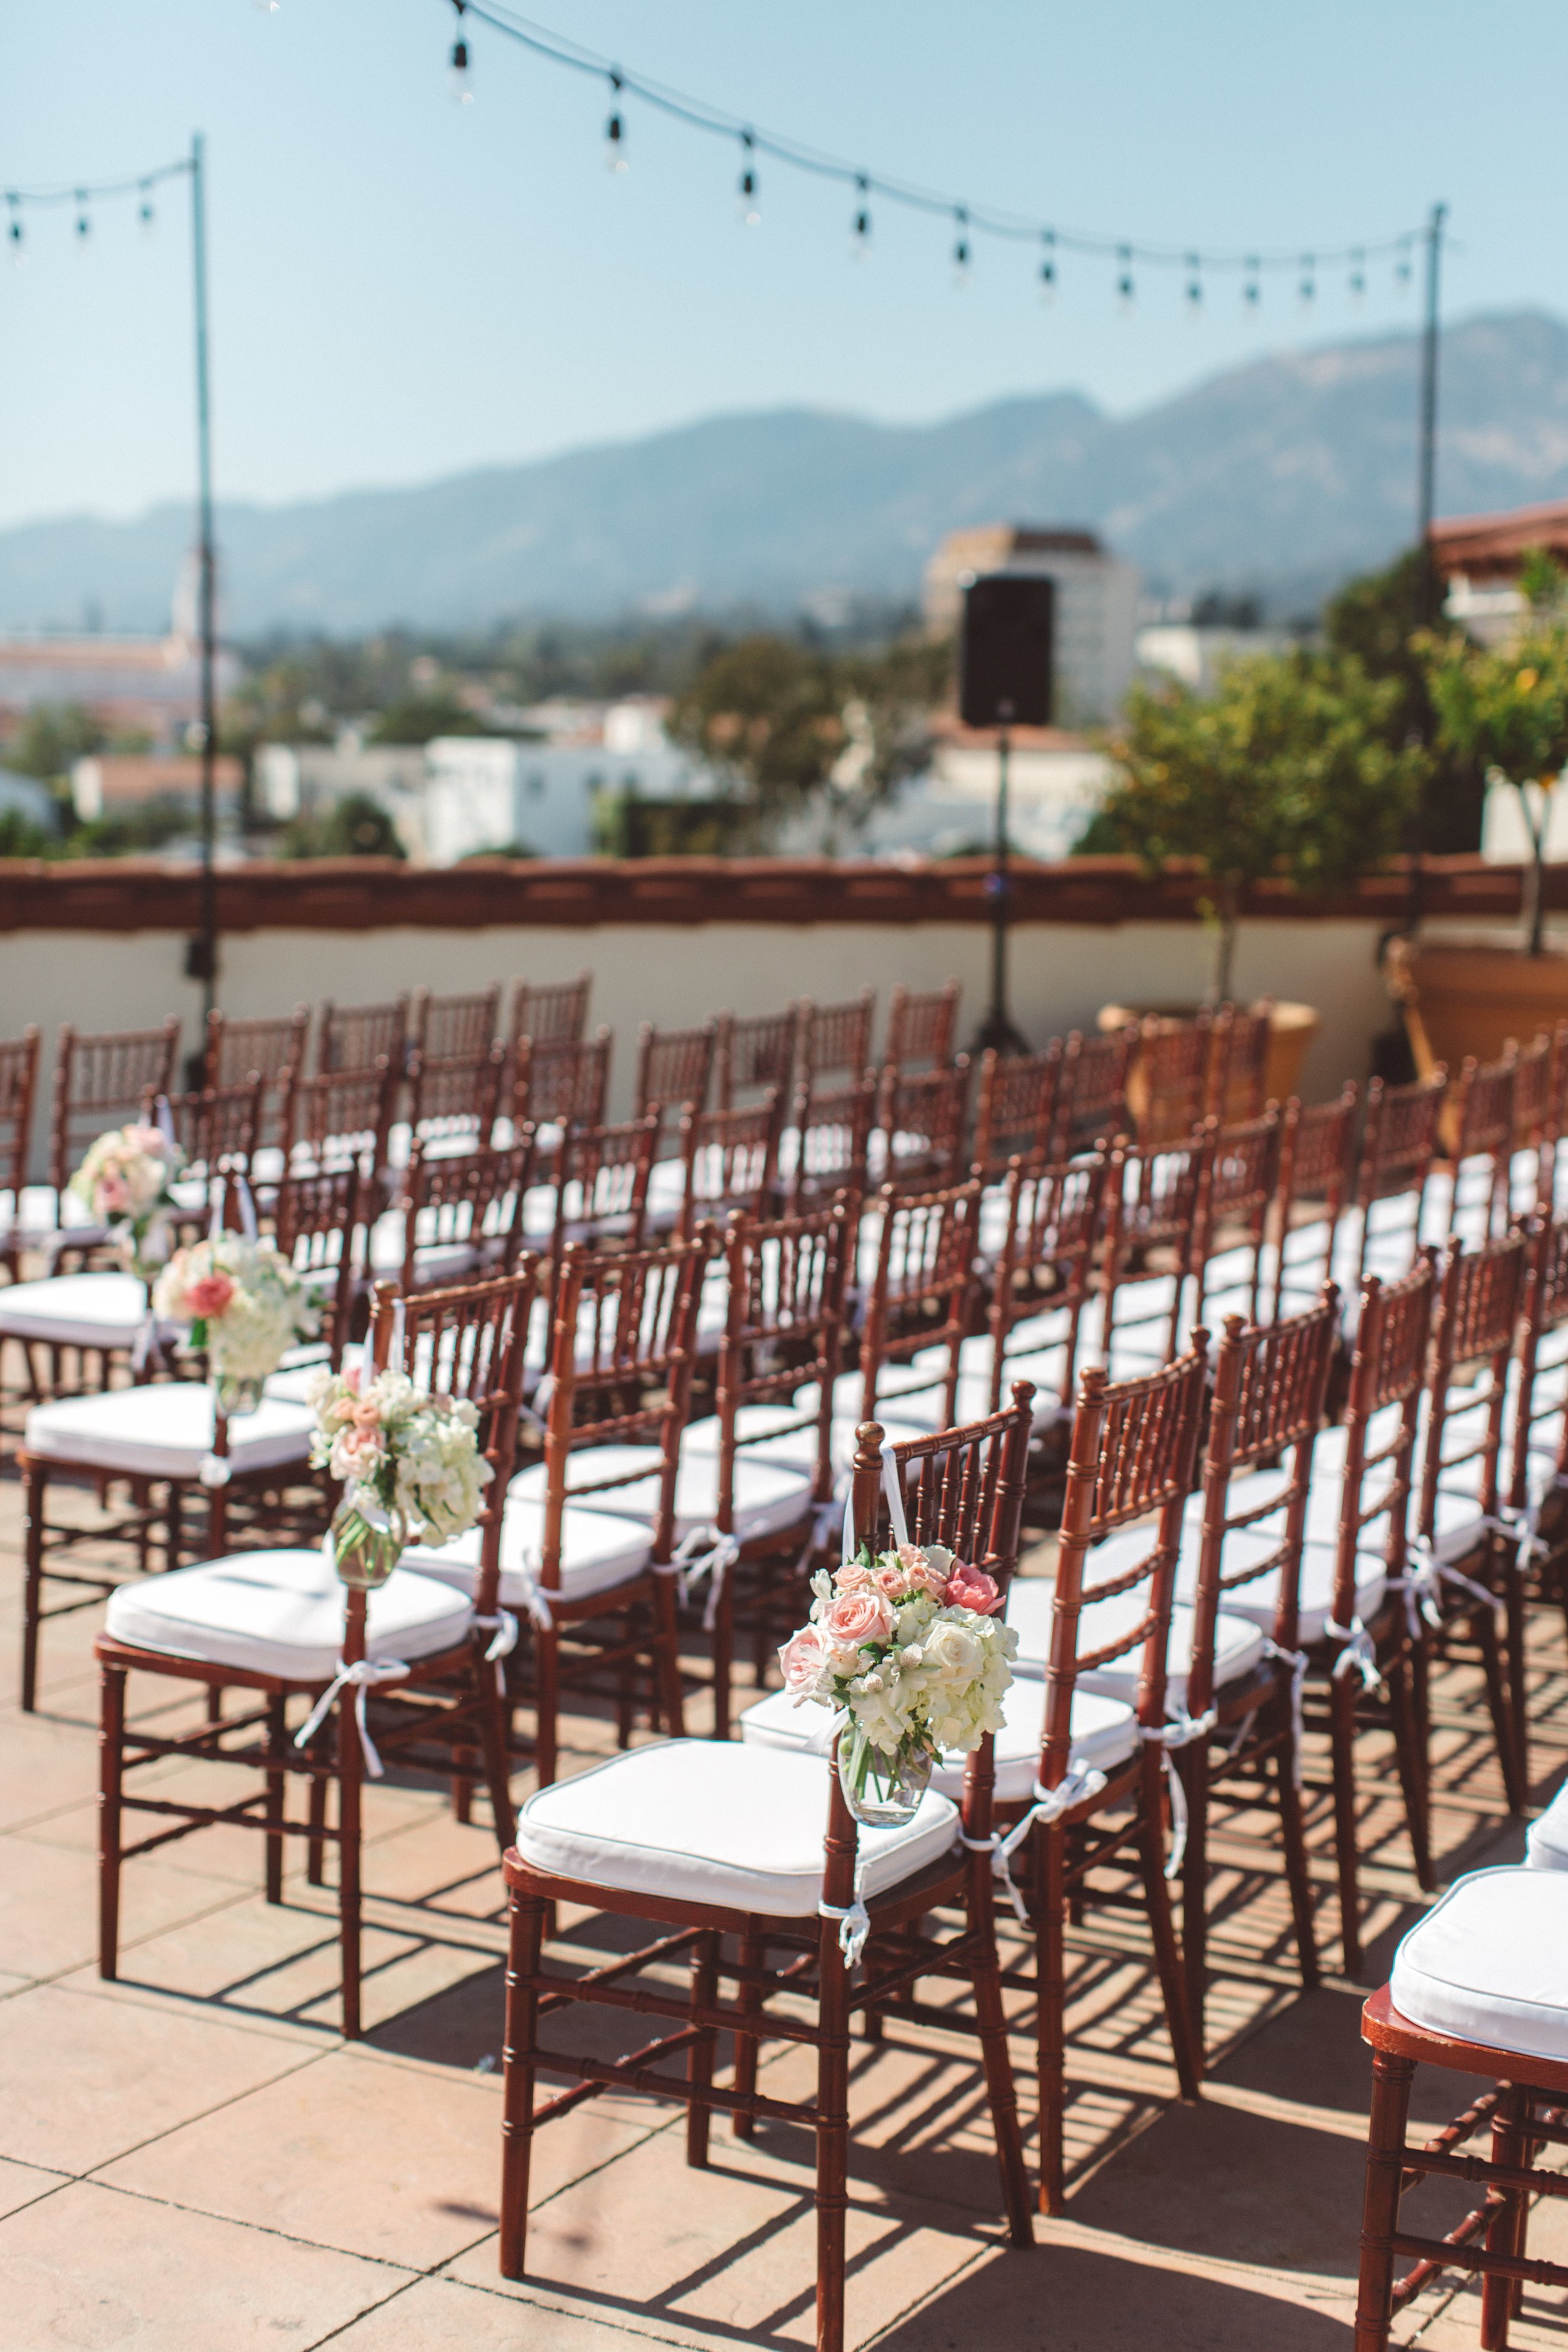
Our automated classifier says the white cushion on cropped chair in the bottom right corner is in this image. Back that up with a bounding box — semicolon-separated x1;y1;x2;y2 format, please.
1389;1870;1568;2065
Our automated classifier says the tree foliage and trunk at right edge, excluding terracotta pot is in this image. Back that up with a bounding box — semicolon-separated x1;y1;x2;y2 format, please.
1424;607;1568;955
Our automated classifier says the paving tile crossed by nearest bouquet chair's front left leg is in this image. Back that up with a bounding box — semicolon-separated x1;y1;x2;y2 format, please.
106;2048;647;2270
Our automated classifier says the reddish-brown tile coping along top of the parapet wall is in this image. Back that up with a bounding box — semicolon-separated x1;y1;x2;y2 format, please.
0;856;1542;934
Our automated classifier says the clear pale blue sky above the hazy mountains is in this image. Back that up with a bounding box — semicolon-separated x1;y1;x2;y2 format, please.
0;0;1568;522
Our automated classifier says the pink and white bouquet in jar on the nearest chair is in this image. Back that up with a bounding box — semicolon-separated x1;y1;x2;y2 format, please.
778;1543;1018;1828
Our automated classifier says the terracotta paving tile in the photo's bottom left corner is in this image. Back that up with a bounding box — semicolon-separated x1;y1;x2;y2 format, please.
0;2180;405;2352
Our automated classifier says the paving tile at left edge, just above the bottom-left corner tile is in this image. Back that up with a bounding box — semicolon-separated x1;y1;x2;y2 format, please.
0;1985;310;2173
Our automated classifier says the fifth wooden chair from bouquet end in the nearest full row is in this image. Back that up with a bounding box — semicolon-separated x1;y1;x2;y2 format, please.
1406;1232;1530;1813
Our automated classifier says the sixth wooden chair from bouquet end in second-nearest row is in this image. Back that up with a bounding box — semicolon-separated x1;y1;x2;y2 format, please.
1100;1129;1216;1379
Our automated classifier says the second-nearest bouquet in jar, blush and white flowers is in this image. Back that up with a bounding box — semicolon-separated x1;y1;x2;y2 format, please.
310;1364;496;1590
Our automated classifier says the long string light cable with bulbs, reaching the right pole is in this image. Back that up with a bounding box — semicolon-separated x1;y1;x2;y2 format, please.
442;0;1427;299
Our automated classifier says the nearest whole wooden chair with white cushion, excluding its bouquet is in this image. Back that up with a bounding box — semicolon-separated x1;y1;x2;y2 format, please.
501;1404;1032;2352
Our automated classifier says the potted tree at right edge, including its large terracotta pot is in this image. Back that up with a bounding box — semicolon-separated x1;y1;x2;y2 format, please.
1389;581;1568;1070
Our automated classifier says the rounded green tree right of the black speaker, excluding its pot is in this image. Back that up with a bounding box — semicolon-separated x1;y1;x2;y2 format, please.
1079;649;1420;1004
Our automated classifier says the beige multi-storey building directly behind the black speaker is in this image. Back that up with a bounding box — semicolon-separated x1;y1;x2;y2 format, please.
924;522;1138;727
